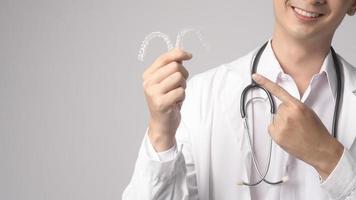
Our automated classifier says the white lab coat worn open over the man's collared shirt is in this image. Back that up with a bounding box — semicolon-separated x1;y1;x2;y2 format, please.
123;47;356;200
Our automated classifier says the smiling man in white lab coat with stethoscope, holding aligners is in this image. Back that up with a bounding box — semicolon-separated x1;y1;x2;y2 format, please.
123;0;356;200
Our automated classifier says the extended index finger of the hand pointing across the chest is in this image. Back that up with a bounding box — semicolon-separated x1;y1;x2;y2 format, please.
252;73;298;104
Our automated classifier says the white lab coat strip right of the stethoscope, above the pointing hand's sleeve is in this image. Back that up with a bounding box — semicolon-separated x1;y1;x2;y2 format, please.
338;62;356;149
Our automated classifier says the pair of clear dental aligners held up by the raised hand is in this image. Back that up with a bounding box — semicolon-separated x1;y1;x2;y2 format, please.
138;28;208;61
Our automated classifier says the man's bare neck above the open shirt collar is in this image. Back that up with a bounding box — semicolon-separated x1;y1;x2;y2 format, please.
272;25;331;95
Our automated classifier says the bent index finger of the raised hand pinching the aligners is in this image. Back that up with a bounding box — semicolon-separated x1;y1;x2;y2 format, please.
147;48;193;74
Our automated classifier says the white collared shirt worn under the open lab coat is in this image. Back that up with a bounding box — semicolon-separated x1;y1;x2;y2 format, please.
241;42;337;200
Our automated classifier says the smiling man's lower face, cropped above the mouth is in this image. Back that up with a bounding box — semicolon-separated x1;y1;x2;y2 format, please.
274;0;356;40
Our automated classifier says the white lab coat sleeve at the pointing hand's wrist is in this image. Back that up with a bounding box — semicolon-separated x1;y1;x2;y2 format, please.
321;148;356;200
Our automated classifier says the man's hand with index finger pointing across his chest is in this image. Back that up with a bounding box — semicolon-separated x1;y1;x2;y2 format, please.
252;74;343;179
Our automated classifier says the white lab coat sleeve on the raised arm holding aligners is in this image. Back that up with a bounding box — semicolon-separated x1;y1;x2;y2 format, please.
122;77;198;200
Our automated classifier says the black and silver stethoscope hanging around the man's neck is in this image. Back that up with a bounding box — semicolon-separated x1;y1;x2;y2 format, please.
238;42;344;186
